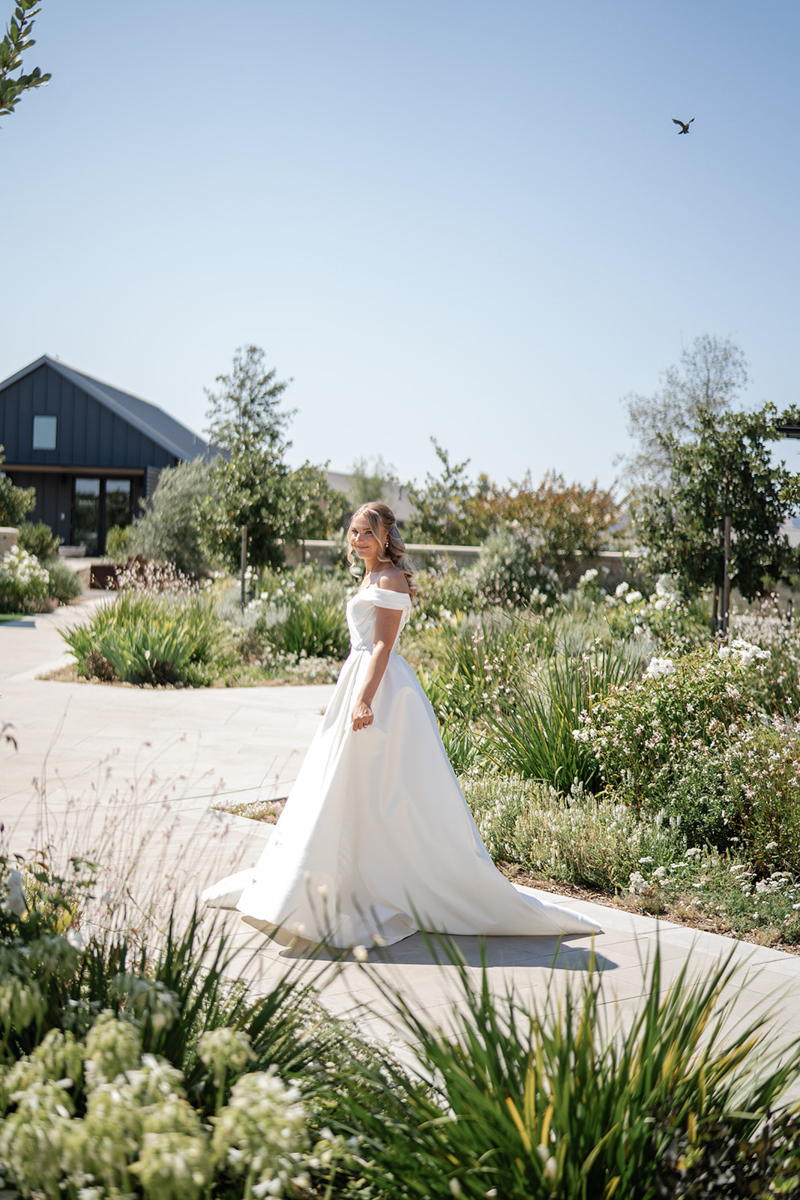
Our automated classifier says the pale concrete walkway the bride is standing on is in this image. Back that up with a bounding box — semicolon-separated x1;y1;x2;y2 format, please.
0;601;800;1084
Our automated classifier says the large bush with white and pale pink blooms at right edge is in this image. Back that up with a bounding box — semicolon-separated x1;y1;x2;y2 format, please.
575;638;800;870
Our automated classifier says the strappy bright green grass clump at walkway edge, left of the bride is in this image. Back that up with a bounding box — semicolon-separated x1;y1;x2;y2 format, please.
61;590;221;684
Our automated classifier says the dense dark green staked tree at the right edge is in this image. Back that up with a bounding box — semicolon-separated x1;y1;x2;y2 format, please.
634;404;800;609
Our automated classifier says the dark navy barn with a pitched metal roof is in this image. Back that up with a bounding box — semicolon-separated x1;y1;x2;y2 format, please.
0;355;215;554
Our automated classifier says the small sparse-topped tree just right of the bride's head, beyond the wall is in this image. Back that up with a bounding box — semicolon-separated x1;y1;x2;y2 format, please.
403;438;489;546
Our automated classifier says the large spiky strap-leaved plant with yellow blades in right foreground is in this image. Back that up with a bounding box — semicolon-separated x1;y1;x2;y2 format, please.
333;942;798;1200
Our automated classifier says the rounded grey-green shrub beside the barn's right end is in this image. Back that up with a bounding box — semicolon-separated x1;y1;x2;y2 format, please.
135;458;212;577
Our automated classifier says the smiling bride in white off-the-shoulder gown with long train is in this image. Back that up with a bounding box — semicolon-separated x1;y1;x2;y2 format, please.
203;503;600;948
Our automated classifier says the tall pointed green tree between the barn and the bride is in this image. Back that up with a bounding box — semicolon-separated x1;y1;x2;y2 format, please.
203;346;343;571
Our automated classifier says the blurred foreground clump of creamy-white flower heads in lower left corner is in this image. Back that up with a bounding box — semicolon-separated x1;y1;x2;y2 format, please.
0;859;331;1200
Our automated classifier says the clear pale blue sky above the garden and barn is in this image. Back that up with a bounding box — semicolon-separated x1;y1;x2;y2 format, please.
0;0;800;485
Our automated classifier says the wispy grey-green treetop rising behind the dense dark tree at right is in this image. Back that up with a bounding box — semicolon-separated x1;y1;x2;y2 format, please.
619;334;747;494
